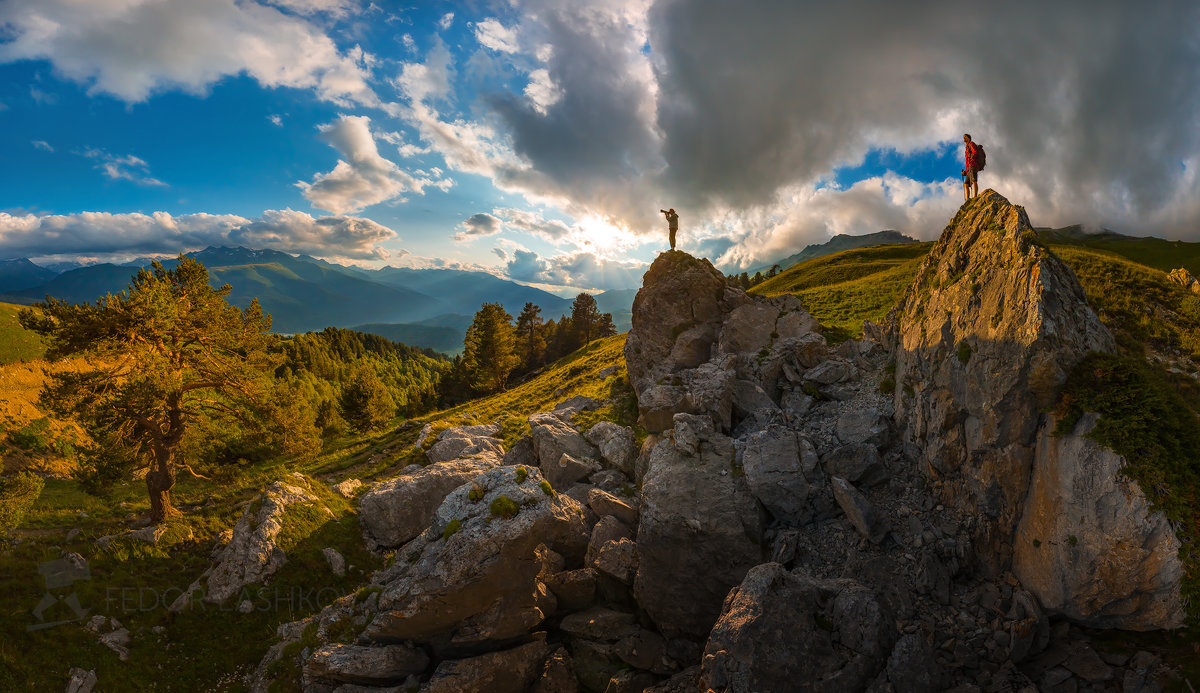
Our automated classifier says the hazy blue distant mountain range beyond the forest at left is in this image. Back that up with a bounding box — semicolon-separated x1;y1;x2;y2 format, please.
0;247;636;352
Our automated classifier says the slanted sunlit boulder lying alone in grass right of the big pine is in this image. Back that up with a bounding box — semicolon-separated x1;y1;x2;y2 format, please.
170;474;332;611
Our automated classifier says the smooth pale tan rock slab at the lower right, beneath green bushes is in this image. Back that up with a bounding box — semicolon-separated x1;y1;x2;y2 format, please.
1013;414;1184;631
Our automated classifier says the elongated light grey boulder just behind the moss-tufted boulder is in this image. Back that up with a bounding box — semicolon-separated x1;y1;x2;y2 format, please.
359;456;500;548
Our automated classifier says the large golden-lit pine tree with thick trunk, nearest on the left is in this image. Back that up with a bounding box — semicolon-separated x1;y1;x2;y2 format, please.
20;255;276;522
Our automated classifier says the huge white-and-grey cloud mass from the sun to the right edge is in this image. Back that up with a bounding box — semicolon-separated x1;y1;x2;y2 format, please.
386;0;1200;265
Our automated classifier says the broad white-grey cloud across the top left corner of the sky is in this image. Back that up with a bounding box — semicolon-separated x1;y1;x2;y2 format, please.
0;0;379;106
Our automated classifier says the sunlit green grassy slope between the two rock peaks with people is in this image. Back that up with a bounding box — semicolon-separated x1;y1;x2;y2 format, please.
751;243;932;341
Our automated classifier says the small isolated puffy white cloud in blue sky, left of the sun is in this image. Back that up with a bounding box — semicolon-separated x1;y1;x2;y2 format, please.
296;115;454;215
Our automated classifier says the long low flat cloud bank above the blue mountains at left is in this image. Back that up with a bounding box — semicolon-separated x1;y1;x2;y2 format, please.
0;210;396;260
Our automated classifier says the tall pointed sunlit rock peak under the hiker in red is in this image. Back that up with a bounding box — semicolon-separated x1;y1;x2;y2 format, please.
887;191;1114;565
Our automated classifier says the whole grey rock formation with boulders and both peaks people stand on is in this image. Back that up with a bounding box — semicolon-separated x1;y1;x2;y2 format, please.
243;191;1184;693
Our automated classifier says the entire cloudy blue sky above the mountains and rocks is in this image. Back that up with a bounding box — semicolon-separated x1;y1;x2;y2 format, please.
0;0;1200;294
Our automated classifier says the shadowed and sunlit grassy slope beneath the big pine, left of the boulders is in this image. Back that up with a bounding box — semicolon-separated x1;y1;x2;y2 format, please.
0;335;636;691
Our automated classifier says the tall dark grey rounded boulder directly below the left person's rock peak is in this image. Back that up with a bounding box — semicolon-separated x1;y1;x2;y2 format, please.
634;414;763;637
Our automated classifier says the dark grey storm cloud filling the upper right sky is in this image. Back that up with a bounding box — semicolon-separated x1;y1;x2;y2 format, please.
649;0;1200;232
